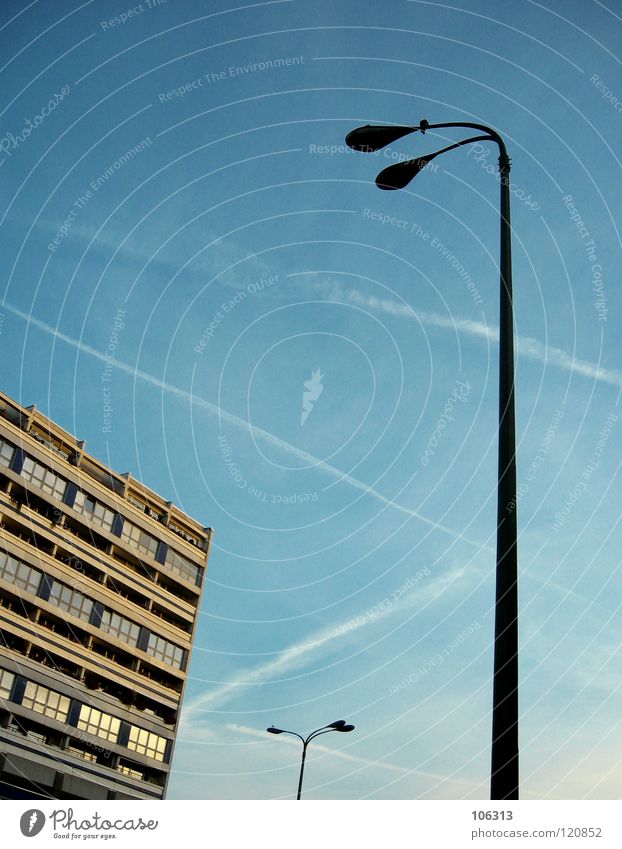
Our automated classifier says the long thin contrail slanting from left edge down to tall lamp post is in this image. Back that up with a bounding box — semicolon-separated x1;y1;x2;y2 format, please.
4;303;485;550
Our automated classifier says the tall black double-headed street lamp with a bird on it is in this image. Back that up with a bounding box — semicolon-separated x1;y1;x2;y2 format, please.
346;120;518;799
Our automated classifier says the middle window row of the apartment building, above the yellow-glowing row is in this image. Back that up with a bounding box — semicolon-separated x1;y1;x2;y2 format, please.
0;551;185;669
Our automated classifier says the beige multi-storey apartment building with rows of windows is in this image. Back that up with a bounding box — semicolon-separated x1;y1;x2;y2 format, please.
0;392;212;799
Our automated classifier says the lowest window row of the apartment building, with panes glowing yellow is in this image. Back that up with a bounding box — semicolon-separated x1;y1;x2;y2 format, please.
0;669;168;762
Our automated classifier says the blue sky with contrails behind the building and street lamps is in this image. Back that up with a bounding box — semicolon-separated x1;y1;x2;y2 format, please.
0;0;622;799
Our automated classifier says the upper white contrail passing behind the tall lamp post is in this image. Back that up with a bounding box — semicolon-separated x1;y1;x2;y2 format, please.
315;281;622;389
